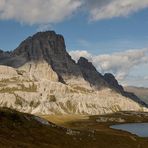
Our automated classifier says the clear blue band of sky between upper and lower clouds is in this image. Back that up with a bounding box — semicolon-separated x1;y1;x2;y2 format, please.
0;9;148;54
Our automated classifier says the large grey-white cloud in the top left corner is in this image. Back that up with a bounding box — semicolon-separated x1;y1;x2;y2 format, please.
0;0;81;24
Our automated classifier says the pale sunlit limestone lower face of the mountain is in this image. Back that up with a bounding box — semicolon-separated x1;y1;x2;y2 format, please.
0;63;148;115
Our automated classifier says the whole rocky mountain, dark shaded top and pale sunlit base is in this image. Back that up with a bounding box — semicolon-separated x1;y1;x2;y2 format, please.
0;31;147;114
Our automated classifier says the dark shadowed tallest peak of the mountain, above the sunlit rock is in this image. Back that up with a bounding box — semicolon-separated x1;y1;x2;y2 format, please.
7;31;82;82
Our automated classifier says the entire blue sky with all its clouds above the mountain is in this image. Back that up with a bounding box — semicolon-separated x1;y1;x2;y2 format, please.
0;0;148;87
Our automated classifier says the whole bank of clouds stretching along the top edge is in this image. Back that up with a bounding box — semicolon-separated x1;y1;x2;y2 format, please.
0;0;148;24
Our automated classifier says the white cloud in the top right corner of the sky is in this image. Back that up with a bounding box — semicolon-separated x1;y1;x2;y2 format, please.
87;0;148;21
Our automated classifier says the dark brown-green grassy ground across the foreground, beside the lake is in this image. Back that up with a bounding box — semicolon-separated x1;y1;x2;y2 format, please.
0;108;148;148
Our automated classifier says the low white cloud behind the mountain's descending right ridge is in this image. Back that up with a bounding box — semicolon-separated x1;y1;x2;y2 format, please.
70;49;148;81
